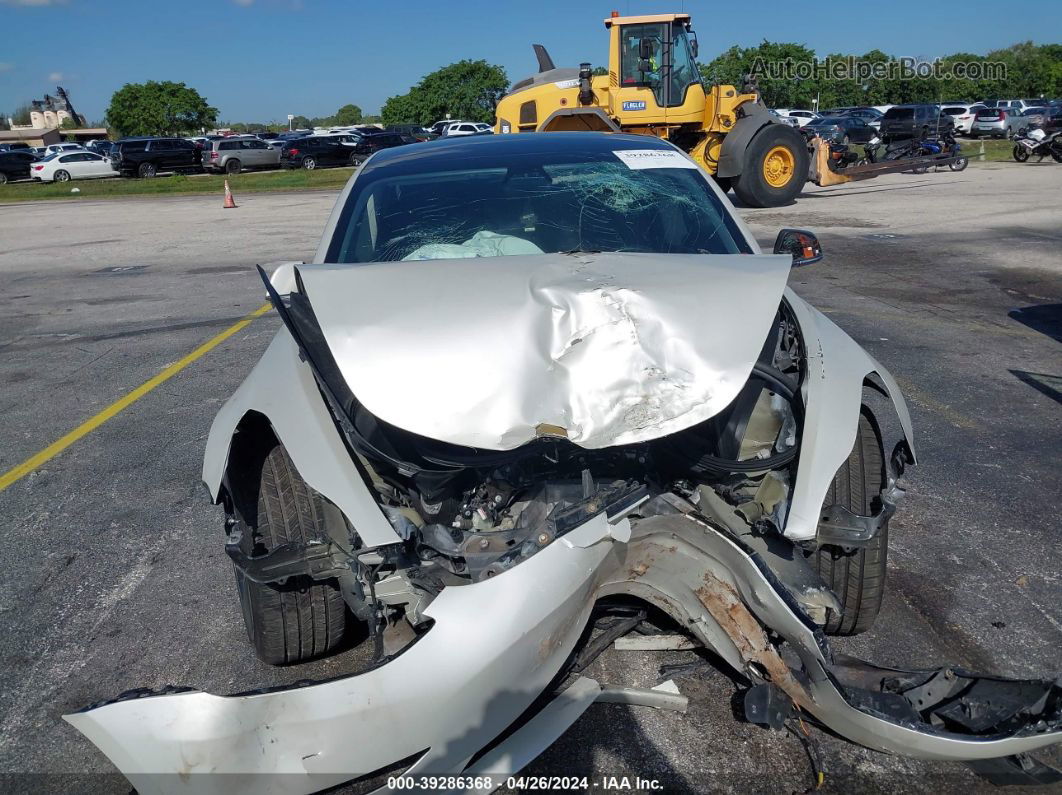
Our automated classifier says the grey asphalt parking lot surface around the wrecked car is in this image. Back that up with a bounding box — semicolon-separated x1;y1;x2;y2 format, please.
0;162;1062;793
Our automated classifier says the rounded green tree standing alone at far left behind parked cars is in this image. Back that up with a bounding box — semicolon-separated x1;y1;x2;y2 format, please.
107;81;218;136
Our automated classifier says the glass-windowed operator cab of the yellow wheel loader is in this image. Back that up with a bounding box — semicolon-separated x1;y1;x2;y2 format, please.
619;18;701;108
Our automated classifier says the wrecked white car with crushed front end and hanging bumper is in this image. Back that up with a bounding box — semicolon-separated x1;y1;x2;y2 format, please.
67;133;1062;795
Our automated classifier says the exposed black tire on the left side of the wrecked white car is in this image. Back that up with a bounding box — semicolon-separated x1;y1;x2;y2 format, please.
236;445;346;666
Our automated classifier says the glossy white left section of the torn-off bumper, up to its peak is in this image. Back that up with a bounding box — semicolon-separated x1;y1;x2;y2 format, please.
64;514;630;795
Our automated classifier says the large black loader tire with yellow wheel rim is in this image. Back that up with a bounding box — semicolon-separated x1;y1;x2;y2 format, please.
733;124;808;207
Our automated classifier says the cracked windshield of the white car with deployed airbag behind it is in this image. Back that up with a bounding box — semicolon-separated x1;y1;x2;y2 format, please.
327;149;750;262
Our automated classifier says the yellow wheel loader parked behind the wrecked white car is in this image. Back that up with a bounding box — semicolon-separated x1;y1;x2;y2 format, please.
495;12;808;207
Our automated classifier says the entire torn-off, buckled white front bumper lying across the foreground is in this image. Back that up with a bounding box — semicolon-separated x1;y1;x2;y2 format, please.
66;506;1062;795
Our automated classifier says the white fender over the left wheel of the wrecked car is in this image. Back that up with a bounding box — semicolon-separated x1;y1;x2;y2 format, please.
203;328;401;547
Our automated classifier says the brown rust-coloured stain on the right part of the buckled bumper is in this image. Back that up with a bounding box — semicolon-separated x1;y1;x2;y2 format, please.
696;574;812;709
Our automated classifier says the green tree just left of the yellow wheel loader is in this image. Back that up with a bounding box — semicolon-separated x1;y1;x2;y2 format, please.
380;61;509;125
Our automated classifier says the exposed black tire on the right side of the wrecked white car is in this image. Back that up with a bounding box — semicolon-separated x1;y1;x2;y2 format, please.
810;413;889;635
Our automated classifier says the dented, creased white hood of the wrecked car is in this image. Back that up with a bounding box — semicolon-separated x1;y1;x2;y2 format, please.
298;253;791;450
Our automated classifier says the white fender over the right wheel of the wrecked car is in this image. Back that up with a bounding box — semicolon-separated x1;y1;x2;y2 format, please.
785;289;914;541
